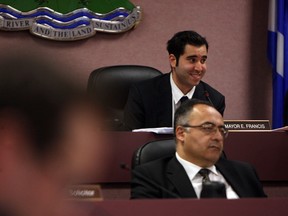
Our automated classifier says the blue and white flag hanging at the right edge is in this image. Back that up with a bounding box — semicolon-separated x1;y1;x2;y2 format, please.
268;0;288;128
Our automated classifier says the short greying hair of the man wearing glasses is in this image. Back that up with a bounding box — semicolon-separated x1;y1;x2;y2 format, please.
174;99;214;133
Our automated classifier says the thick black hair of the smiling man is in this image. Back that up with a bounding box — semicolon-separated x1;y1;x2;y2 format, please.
167;31;209;65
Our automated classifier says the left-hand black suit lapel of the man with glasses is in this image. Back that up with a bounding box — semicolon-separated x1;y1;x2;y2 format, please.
166;157;196;198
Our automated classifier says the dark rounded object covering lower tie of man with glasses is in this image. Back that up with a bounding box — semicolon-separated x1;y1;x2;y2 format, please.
200;181;227;198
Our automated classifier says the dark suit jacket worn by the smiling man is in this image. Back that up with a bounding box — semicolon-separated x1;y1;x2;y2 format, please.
124;73;225;130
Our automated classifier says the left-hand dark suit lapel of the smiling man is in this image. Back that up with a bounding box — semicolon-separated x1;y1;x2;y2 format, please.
155;73;172;126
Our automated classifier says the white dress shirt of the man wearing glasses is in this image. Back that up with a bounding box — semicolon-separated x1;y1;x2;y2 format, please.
176;152;239;199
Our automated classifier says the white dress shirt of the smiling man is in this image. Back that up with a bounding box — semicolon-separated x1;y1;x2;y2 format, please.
170;73;196;125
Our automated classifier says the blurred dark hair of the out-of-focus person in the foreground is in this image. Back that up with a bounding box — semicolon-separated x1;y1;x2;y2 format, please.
0;51;84;163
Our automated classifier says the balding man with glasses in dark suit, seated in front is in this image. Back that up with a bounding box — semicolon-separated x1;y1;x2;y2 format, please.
131;100;266;199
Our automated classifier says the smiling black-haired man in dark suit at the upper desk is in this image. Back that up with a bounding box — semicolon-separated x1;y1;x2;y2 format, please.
124;31;225;130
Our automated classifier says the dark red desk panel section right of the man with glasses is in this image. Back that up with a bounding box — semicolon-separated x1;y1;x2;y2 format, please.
225;132;288;182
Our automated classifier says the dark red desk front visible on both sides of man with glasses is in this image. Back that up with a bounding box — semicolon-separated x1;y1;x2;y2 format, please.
91;132;288;183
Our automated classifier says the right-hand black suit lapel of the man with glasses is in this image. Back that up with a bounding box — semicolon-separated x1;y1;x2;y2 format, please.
215;158;245;197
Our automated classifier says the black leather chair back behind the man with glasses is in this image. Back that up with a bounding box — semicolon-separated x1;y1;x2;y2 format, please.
131;139;176;169
